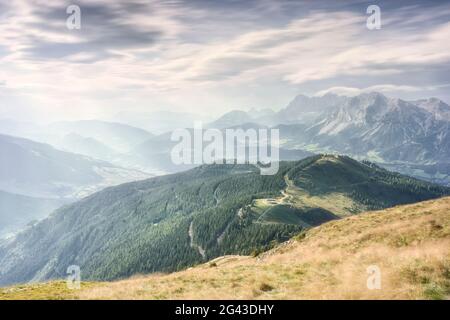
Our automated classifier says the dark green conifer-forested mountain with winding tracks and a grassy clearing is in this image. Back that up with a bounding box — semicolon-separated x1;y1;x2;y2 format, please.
0;156;450;284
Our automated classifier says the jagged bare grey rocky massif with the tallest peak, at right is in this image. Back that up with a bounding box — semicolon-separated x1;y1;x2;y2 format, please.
302;93;450;163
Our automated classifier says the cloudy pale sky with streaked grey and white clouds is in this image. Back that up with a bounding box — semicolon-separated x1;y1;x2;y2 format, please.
0;0;450;121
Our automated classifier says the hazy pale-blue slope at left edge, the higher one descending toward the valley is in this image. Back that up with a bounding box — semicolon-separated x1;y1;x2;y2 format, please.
0;135;148;198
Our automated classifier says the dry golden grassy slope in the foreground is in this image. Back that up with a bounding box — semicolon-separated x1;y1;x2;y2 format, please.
0;197;450;299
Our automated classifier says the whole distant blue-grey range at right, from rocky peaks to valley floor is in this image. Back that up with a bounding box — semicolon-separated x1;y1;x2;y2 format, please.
209;92;450;185
